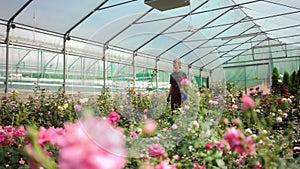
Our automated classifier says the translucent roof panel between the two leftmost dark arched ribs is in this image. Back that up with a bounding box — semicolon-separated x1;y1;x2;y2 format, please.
15;0;102;33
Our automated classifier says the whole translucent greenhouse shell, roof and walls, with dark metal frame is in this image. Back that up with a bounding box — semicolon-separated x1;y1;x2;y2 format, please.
0;0;300;93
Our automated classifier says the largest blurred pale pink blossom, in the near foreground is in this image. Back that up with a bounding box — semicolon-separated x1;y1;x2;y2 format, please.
57;118;126;169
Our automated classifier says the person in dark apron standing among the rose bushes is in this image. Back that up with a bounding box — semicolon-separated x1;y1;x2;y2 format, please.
167;59;187;111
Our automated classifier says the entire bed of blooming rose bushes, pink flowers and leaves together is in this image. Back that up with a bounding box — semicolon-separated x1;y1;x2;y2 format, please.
0;76;299;169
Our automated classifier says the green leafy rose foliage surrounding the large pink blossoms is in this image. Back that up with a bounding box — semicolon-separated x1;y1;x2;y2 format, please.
0;76;300;169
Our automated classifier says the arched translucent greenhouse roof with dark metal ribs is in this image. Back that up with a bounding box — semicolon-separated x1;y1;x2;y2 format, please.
0;0;300;70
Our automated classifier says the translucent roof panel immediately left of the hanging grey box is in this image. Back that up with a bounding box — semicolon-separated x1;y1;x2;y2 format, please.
72;1;147;43
